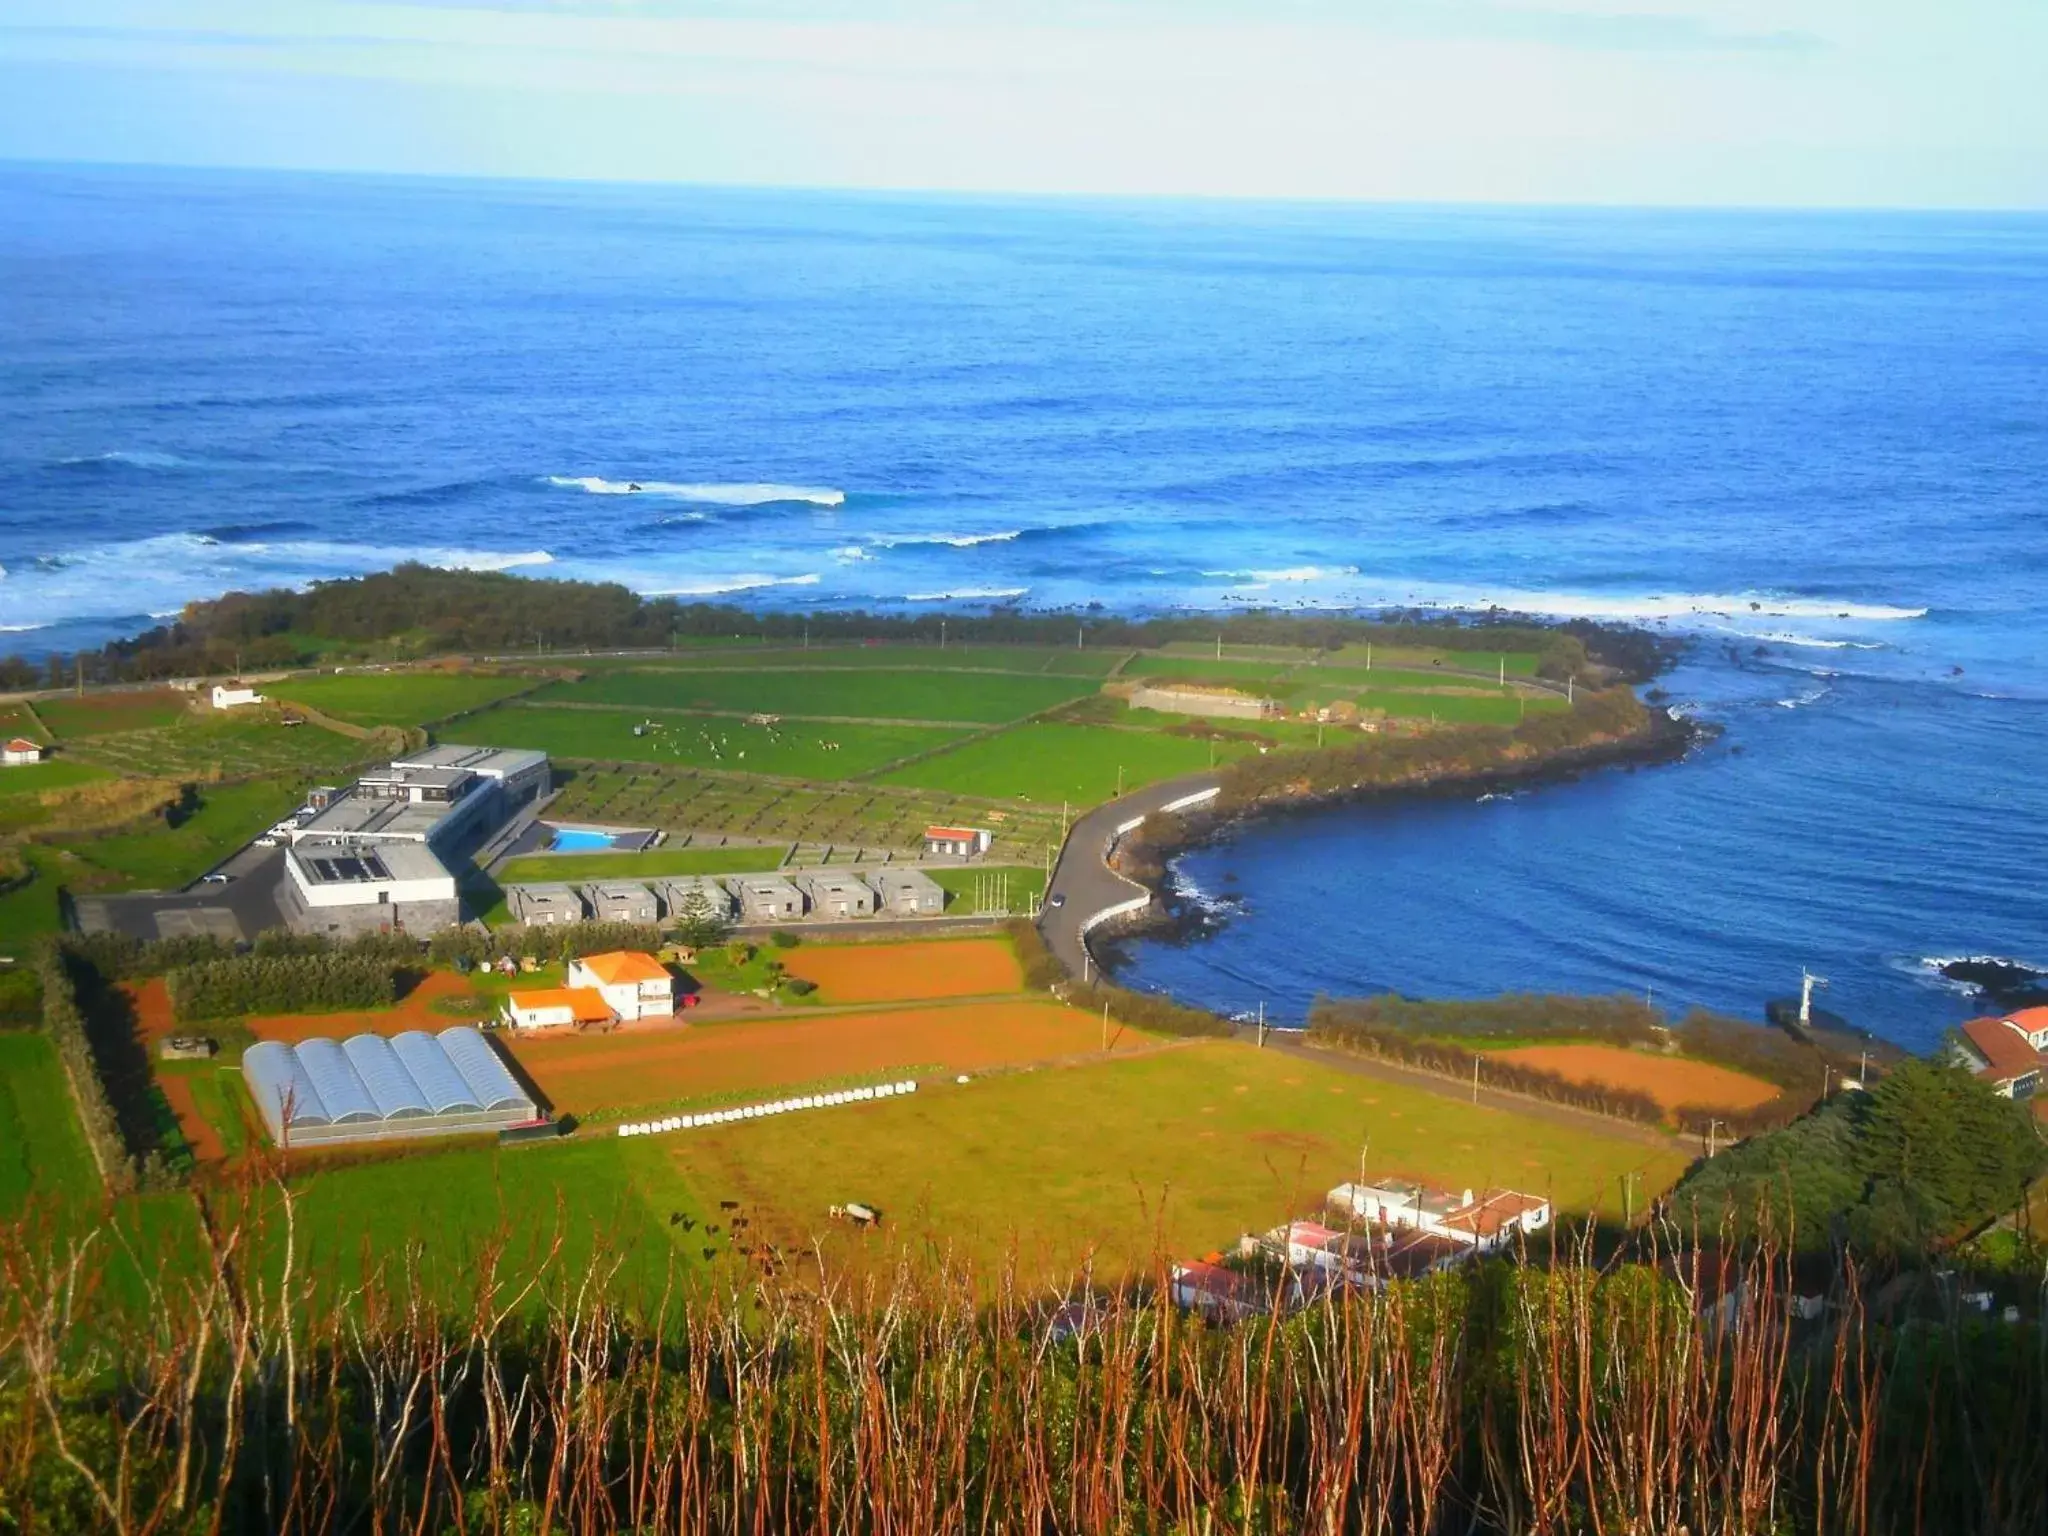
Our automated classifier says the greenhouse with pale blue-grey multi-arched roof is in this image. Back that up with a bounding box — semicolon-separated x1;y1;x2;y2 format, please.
242;1024;541;1147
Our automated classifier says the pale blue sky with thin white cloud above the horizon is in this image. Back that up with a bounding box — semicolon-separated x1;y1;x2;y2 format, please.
0;0;2048;209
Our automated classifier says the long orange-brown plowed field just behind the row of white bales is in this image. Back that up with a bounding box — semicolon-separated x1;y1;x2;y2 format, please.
508;1001;1153;1114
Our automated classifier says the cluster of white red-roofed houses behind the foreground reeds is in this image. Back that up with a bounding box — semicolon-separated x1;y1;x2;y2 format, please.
1171;1182;1550;1323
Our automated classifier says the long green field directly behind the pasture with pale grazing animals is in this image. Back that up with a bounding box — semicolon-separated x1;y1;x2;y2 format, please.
541;668;1092;725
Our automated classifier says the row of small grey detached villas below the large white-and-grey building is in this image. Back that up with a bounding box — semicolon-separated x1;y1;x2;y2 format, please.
506;866;946;926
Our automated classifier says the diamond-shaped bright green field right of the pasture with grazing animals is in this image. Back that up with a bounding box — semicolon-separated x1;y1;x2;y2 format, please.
881;721;1257;807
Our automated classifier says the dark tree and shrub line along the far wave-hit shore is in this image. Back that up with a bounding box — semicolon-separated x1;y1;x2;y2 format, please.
0;565;1675;688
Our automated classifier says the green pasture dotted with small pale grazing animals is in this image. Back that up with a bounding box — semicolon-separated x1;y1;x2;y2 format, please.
463;705;961;778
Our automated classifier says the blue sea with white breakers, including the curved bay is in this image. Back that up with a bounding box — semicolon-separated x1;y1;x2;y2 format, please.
0;166;2048;1044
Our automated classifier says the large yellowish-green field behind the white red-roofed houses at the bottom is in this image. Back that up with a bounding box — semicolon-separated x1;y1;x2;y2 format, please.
647;1040;1681;1278
